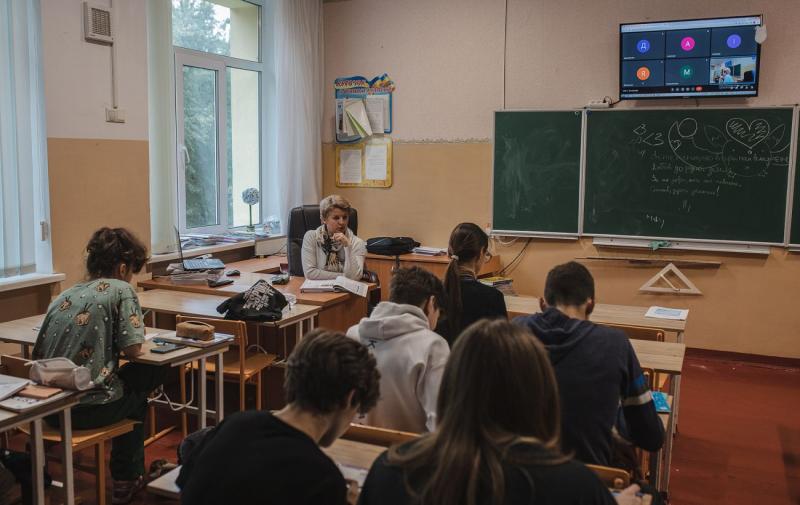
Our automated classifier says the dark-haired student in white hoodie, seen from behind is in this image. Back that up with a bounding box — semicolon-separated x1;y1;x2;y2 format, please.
347;267;450;433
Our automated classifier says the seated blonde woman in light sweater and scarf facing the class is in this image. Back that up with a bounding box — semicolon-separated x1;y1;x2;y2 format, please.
302;195;367;281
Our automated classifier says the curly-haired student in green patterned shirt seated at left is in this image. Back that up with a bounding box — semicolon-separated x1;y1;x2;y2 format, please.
33;228;164;504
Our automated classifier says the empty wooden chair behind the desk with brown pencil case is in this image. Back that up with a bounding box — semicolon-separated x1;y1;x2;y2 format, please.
175;315;277;426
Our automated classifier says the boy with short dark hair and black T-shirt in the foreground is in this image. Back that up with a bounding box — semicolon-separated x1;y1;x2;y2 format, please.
177;329;380;505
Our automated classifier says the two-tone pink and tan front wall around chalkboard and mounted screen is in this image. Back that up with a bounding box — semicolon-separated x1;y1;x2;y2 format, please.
323;0;800;358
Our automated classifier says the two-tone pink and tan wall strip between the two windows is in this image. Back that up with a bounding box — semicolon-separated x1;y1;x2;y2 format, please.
42;0;150;287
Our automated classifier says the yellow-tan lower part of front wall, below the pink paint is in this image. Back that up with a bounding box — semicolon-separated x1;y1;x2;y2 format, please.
323;143;800;358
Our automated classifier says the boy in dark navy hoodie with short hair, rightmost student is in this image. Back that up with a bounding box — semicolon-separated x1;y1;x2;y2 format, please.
514;261;664;465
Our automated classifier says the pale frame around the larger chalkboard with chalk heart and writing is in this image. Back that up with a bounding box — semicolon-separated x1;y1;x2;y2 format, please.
581;105;800;250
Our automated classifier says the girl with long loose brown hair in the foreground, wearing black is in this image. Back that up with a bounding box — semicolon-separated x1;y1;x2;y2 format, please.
360;320;624;505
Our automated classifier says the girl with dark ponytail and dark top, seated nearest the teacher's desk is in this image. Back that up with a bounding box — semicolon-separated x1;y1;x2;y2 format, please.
436;223;508;347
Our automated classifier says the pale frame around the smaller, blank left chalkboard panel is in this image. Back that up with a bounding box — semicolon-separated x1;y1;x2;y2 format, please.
489;108;586;241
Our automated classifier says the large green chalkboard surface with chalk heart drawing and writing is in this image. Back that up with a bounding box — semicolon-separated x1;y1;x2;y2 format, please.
583;107;792;243
